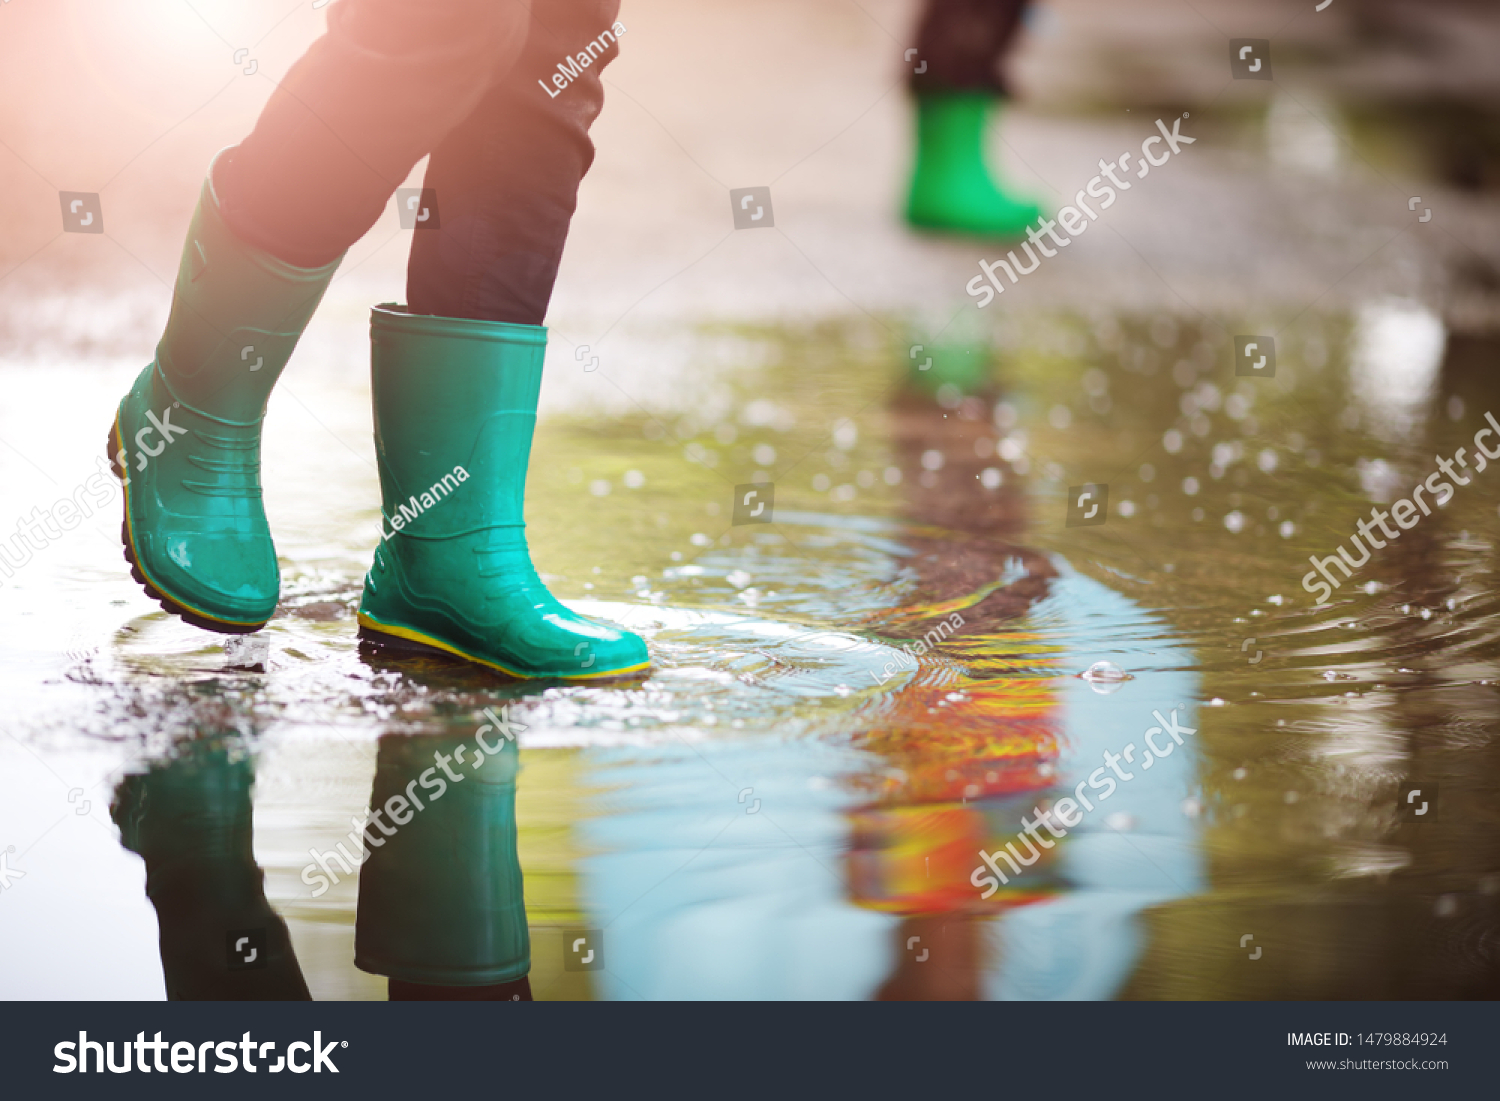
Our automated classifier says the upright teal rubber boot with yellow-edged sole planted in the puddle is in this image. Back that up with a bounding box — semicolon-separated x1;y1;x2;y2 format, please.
360;306;650;680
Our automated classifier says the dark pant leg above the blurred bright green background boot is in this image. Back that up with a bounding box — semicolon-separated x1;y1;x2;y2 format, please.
912;0;1028;95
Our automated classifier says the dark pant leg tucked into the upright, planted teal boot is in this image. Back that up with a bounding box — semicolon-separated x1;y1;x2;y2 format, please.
407;0;620;326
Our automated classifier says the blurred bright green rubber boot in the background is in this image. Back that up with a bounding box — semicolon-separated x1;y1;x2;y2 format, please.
906;92;1041;237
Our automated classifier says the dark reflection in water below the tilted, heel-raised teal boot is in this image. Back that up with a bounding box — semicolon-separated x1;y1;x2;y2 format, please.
110;738;309;1001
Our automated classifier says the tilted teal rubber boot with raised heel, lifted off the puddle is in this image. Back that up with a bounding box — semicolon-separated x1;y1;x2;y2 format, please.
110;157;339;635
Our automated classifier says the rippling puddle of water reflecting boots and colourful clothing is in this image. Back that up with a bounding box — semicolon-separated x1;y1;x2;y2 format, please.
0;310;1500;999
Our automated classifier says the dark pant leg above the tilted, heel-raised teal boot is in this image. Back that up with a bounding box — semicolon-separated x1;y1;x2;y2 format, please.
215;0;540;267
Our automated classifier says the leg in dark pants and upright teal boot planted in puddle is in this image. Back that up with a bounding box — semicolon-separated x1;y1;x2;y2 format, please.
359;0;648;678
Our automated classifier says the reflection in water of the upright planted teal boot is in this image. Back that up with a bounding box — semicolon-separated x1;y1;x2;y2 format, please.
354;731;531;1001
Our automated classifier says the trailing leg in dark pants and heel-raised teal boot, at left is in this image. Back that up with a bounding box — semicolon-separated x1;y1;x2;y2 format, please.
110;0;545;633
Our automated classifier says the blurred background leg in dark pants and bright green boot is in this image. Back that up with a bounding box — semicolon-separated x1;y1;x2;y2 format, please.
906;0;1041;237
